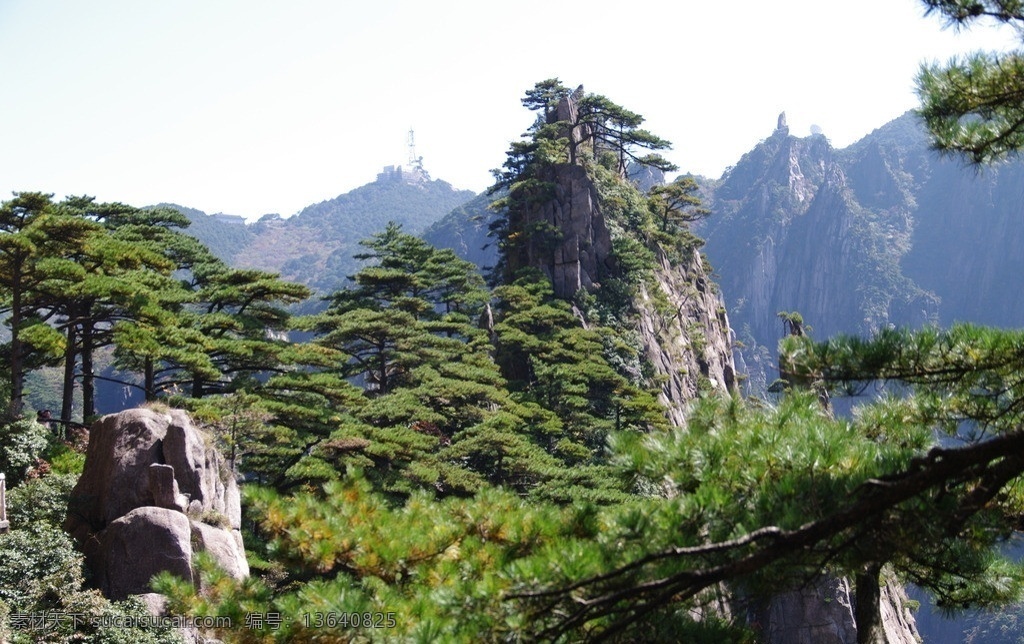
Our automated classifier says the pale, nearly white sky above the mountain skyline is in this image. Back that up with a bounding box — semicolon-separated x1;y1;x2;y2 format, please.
0;0;1017;219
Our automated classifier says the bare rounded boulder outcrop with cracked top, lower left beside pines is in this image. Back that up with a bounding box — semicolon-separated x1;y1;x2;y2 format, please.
66;409;249;599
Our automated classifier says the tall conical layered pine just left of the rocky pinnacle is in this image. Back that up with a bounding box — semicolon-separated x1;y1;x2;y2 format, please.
292;225;573;495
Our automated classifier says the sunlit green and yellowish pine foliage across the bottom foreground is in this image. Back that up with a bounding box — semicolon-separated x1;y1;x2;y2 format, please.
163;395;950;641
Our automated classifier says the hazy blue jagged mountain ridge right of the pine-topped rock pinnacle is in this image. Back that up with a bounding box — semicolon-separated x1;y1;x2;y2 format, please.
699;113;1024;391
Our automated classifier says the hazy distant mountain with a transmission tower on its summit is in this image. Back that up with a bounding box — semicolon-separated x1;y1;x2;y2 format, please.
171;168;475;293
